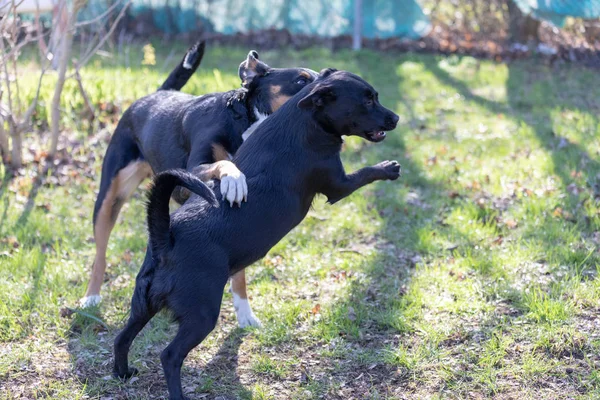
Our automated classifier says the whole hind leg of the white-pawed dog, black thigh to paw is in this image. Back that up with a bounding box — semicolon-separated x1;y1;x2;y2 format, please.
80;134;152;307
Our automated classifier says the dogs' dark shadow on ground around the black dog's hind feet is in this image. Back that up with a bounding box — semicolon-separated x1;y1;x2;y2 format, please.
61;309;252;399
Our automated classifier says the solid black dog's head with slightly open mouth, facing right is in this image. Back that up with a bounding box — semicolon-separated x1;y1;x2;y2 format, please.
298;68;399;142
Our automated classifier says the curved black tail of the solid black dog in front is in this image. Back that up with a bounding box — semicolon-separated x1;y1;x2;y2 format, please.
147;169;219;253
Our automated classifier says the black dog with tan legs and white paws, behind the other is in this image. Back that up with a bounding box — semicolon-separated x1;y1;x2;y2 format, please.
81;42;317;327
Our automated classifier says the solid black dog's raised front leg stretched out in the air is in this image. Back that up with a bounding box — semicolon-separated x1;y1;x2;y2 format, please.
323;161;401;204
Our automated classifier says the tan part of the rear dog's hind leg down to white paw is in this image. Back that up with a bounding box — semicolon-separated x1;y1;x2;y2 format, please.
82;161;152;304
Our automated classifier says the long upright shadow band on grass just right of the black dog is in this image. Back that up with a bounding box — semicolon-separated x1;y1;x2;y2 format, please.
276;54;488;398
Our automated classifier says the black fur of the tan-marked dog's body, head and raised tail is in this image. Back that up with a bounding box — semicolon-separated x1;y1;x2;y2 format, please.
94;42;317;225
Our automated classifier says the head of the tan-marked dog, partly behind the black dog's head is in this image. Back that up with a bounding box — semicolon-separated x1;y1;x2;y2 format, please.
238;50;318;115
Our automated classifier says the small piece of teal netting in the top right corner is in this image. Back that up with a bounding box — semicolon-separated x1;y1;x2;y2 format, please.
513;0;600;26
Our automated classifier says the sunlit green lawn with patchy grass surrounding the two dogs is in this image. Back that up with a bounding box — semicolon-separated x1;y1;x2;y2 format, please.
0;47;600;400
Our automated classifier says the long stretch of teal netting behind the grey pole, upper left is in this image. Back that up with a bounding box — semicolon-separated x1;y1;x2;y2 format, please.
81;0;430;38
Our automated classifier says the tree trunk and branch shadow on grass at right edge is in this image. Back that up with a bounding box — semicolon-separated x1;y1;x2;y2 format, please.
424;60;600;275
